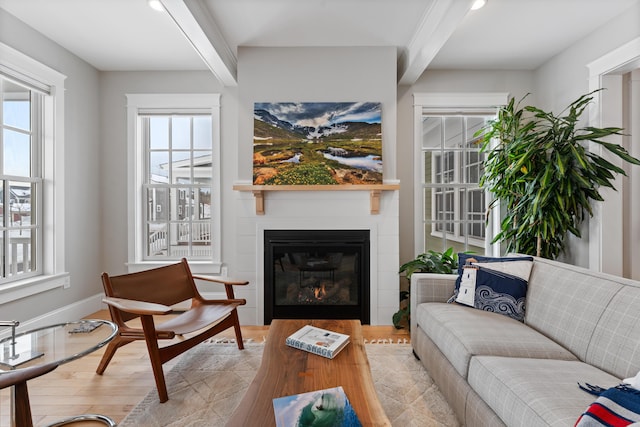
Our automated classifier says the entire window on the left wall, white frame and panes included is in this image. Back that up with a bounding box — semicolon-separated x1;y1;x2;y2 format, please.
0;43;68;304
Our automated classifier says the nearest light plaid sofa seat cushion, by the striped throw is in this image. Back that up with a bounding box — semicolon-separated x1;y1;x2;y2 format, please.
469;356;620;427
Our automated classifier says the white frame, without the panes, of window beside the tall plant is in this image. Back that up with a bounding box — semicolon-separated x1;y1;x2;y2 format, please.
413;92;509;256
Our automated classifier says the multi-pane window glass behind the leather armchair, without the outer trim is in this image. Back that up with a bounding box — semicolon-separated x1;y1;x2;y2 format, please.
140;114;212;259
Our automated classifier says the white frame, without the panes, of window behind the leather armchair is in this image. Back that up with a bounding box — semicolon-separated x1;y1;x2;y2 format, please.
126;94;222;274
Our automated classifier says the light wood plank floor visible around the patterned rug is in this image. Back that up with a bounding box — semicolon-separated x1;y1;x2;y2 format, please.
0;310;409;427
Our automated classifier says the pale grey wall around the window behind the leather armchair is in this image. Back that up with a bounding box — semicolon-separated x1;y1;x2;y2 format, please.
99;71;232;274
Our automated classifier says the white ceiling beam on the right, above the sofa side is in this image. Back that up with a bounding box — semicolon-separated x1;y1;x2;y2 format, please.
398;0;473;85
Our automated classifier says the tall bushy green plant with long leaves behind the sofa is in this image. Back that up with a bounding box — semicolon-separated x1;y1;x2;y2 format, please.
476;91;640;259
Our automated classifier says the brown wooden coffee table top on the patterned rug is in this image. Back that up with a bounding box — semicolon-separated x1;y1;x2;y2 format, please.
227;319;391;427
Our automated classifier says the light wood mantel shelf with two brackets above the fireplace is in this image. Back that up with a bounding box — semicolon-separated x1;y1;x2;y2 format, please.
233;184;400;215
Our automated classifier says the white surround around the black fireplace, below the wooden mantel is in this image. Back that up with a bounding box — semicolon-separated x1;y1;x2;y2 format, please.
230;191;399;325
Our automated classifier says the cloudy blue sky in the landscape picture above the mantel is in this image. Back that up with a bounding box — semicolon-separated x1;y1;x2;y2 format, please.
254;102;381;127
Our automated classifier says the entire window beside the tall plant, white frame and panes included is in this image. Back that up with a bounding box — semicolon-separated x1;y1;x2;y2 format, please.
414;94;506;254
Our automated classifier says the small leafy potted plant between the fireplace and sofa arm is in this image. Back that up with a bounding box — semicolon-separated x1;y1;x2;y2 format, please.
392;248;458;329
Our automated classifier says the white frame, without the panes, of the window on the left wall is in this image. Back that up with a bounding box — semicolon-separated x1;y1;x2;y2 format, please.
0;43;70;304
